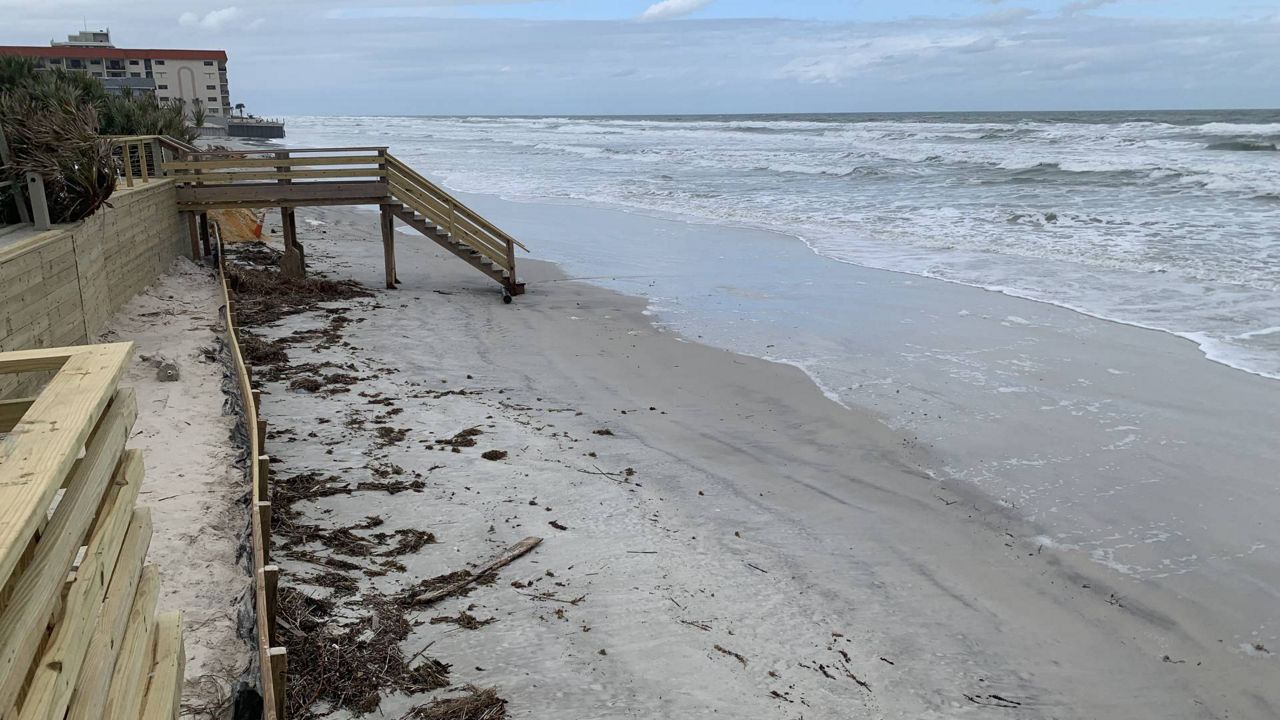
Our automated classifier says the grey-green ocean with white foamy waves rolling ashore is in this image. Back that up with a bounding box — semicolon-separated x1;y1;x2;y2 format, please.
289;110;1280;378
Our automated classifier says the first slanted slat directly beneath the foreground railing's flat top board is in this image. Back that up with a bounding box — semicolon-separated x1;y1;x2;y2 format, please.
0;386;142;707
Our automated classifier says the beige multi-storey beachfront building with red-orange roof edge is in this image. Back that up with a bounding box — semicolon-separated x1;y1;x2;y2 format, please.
0;31;232;124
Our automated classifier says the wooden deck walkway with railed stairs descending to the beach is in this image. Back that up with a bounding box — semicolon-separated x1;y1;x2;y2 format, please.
161;147;527;297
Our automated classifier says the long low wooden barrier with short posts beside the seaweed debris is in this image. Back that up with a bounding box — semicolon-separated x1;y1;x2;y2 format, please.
214;237;288;720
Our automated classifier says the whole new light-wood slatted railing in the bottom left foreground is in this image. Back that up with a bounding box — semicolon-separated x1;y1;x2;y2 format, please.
0;343;184;720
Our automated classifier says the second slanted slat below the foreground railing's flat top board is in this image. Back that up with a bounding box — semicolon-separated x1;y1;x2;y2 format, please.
18;481;151;720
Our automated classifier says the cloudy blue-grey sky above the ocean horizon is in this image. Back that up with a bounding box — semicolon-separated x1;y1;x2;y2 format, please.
0;0;1280;115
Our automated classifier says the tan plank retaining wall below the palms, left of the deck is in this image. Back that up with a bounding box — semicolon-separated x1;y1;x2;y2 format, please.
0;179;191;397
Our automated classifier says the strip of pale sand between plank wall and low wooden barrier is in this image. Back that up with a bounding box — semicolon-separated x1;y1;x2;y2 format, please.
100;258;250;717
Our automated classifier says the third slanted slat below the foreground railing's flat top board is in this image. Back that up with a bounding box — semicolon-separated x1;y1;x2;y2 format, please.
59;507;151;720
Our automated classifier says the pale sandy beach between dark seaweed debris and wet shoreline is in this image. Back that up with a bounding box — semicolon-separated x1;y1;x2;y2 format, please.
232;202;1277;719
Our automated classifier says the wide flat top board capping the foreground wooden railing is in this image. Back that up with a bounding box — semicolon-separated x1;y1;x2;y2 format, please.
0;342;134;594
